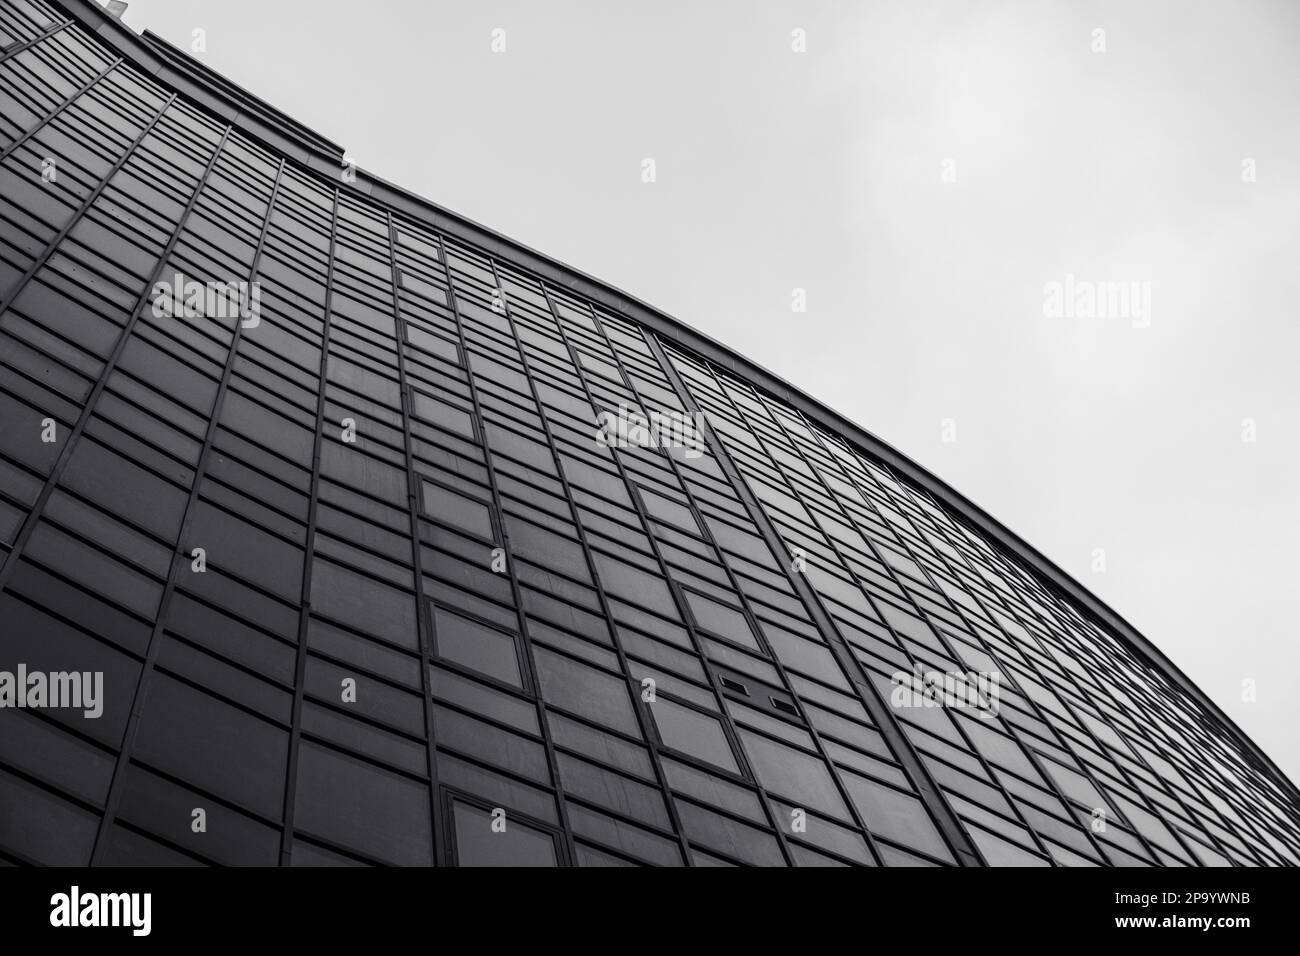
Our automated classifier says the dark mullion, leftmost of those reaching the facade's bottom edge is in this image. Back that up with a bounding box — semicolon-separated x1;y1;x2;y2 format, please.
91;160;285;865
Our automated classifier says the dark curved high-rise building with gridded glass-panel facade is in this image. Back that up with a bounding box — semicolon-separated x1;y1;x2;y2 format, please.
0;0;1300;866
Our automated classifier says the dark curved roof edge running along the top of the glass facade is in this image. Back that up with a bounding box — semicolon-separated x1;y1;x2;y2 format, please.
49;0;1300;804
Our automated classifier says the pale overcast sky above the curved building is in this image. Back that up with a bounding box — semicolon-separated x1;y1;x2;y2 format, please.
114;0;1300;780
